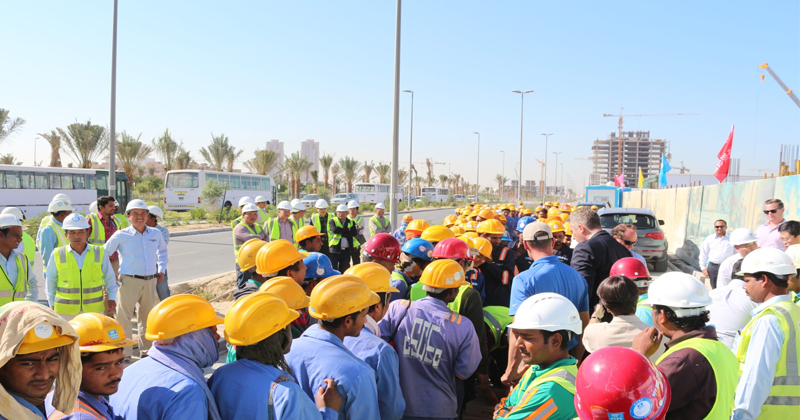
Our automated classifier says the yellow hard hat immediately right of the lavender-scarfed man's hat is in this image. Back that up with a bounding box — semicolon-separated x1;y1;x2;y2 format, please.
224;292;300;346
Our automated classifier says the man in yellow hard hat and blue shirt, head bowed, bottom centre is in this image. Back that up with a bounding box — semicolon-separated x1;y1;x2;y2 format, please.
286;274;380;419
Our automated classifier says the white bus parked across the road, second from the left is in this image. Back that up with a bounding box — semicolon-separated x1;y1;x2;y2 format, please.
164;169;278;211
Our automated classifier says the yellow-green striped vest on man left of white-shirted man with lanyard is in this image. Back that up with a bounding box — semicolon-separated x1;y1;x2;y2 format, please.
53;245;105;315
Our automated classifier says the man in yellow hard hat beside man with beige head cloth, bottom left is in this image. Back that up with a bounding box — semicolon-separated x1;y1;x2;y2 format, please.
45;313;136;420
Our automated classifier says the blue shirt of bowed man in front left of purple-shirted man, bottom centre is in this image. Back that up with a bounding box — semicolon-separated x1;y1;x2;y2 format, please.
286;325;381;420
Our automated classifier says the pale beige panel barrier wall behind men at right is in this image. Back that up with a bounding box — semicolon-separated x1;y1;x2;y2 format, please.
623;175;800;269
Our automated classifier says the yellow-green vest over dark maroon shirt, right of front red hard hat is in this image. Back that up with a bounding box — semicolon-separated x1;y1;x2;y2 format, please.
656;338;739;420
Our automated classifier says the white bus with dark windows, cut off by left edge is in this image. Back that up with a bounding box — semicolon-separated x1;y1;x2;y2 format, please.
0;165;130;217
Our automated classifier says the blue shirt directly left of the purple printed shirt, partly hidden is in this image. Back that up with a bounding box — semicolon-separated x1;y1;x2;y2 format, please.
344;327;406;420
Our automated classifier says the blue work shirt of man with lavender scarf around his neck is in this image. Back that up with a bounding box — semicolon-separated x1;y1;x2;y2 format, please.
111;354;208;420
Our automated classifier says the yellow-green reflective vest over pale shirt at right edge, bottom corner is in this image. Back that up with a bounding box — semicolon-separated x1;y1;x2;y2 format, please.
736;301;800;419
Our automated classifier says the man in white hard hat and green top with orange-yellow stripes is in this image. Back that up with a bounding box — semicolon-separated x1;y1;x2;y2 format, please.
494;293;583;420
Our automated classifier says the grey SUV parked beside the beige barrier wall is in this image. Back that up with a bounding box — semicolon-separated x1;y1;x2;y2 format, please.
597;207;669;272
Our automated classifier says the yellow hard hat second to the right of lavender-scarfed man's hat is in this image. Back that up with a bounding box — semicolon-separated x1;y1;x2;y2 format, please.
308;274;381;321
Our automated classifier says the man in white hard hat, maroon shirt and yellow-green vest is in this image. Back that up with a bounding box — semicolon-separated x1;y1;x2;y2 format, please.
633;271;736;419
